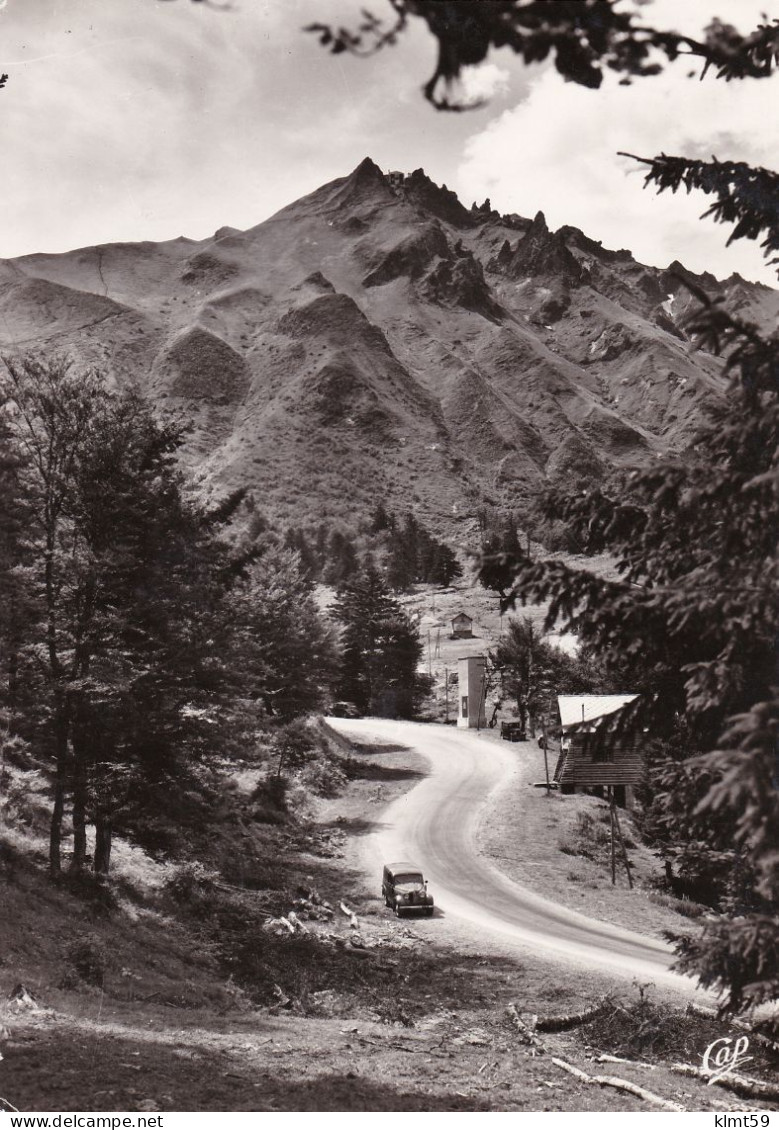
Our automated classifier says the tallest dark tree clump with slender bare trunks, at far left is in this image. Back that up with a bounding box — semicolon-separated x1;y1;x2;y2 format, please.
2;358;246;877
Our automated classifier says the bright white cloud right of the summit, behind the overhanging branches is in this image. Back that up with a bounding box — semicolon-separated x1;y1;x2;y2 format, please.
456;60;779;285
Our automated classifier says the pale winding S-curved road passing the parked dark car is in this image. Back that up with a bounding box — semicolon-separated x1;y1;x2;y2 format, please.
327;718;698;994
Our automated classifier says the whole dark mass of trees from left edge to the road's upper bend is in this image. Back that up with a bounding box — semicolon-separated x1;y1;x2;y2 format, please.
0;356;438;879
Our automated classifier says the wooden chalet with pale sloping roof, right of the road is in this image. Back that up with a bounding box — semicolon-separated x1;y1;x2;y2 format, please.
554;695;646;808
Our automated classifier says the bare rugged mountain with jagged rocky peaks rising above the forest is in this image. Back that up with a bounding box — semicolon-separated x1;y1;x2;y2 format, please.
0;158;779;541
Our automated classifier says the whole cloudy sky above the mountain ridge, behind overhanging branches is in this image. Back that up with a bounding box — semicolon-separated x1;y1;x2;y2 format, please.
0;0;779;285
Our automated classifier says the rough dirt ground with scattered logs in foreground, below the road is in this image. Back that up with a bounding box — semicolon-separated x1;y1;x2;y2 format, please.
0;732;776;1112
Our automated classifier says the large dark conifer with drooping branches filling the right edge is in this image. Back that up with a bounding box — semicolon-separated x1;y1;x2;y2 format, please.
495;309;779;1009
